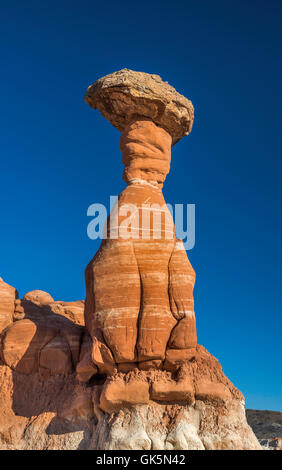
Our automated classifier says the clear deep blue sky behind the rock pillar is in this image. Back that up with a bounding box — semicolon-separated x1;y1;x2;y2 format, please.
0;0;282;411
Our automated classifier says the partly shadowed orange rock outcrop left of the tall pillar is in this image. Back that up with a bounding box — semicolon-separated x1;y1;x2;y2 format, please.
0;300;95;449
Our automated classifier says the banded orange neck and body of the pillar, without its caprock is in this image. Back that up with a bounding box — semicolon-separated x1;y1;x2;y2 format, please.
85;119;197;370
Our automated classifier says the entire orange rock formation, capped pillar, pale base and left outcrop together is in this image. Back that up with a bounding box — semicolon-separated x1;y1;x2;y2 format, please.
0;69;260;450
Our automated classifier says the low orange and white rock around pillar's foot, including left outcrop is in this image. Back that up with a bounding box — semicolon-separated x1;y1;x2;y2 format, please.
0;278;262;450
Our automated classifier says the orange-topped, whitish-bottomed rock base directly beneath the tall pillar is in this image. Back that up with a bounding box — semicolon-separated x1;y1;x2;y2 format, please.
87;346;261;450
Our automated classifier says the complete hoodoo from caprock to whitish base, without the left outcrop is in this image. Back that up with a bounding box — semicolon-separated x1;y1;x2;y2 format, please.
79;69;260;449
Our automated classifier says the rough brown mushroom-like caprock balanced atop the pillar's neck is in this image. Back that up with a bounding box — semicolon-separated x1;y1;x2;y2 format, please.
85;69;194;144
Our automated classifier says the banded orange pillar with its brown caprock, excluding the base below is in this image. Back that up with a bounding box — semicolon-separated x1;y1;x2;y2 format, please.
85;70;197;374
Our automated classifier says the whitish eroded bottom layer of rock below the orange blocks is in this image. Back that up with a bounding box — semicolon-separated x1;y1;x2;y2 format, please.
94;400;261;450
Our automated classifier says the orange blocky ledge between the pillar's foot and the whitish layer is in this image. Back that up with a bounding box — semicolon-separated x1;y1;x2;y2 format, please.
100;345;240;412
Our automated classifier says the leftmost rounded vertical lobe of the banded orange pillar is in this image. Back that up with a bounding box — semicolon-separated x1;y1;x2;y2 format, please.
85;240;140;365
